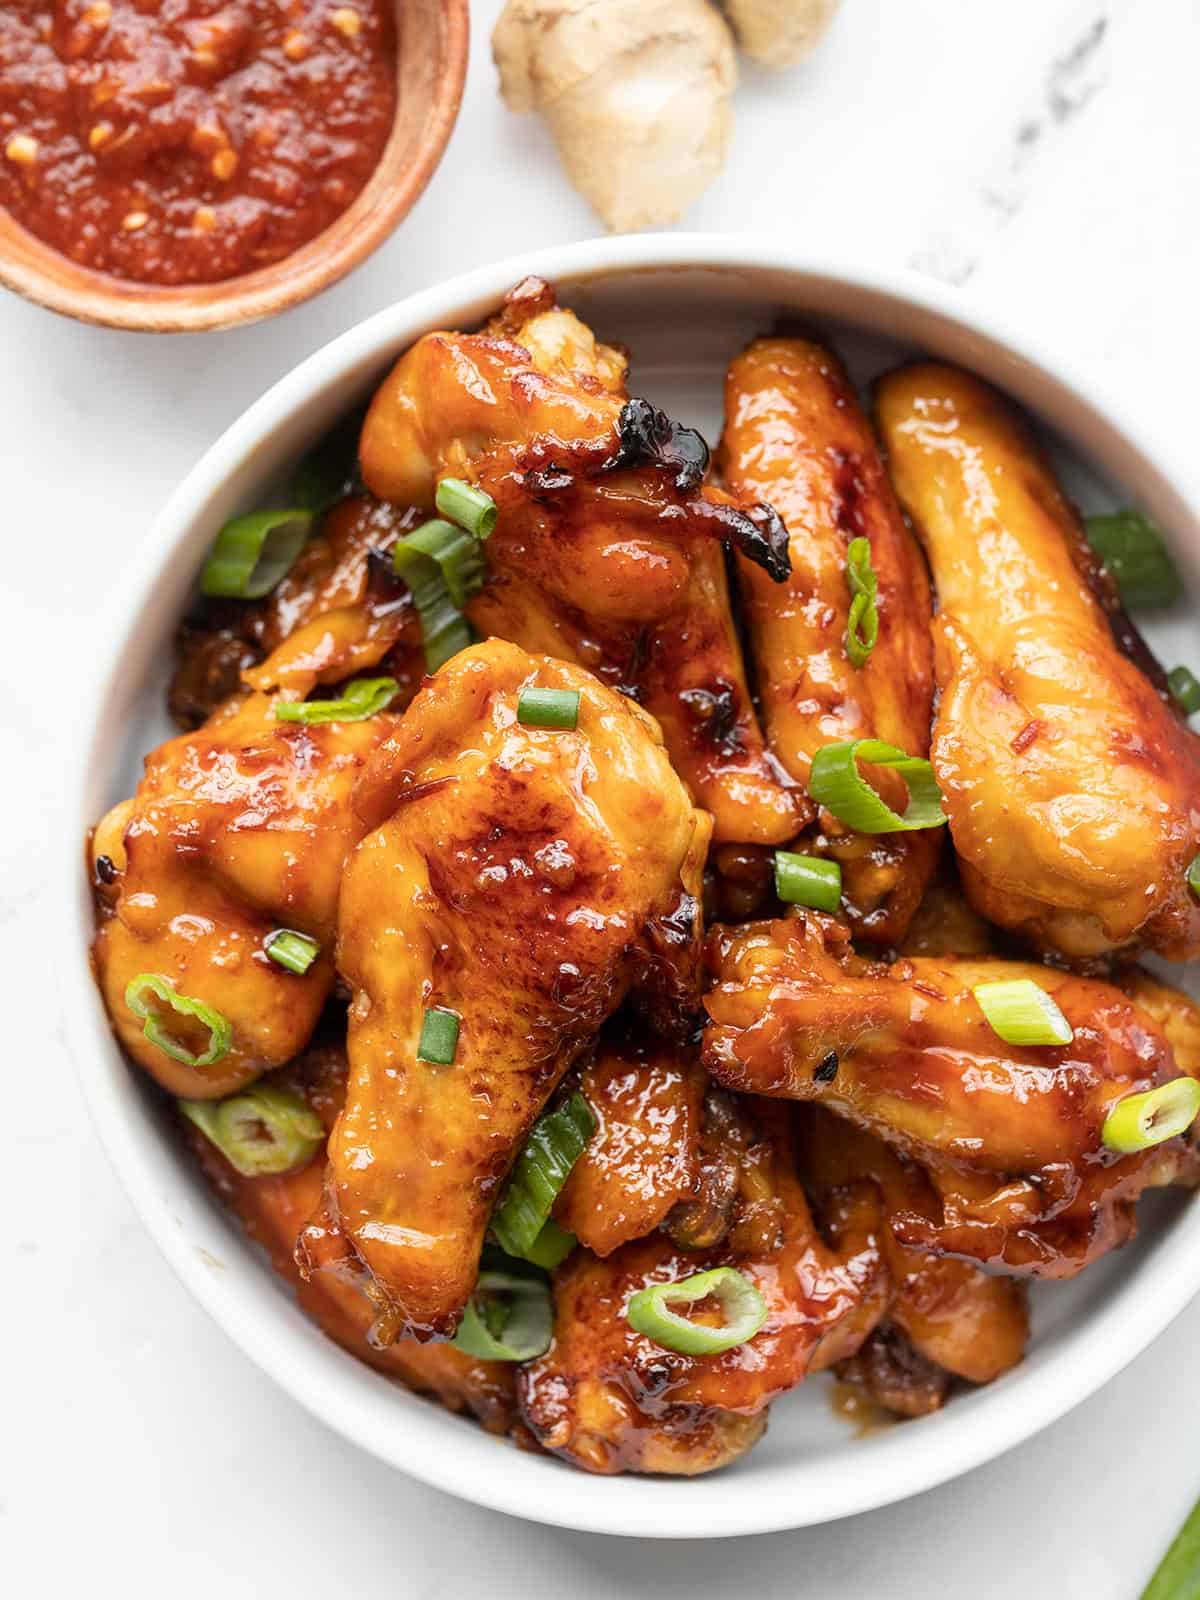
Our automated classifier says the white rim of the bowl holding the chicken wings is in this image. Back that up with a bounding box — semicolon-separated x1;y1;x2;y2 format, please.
63;234;1200;1538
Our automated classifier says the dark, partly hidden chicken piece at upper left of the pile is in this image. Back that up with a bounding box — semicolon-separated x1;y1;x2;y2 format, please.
168;494;424;730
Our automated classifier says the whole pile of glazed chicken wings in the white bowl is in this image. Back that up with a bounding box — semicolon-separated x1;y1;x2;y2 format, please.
88;280;1200;1475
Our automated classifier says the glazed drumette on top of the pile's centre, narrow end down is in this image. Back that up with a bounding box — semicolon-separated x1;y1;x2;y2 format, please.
330;640;709;1342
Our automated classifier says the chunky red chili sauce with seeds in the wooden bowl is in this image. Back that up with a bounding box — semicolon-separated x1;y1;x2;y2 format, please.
0;0;395;283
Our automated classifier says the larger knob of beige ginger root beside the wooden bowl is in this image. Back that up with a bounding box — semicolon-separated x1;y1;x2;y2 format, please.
491;0;739;232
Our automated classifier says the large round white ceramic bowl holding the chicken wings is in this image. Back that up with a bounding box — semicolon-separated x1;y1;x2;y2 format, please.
61;234;1200;1538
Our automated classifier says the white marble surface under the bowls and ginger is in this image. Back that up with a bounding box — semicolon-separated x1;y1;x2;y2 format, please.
0;0;1200;1600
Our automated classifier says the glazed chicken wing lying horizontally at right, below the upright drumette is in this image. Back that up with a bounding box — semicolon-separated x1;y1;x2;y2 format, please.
704;914;1197;1277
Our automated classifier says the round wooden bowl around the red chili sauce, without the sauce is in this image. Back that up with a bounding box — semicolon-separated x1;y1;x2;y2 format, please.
0;0;470;333
